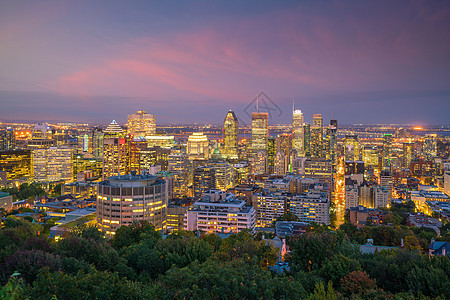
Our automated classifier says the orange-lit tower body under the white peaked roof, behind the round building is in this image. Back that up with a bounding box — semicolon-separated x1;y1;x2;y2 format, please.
102;138;129;180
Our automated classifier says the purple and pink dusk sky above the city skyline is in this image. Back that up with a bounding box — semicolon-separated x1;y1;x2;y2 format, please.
0;0;450;125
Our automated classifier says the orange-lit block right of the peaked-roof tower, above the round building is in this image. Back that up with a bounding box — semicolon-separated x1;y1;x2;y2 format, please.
128;140;158;174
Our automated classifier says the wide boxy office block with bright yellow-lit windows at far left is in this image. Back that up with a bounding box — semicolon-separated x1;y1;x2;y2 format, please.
32;147;73;181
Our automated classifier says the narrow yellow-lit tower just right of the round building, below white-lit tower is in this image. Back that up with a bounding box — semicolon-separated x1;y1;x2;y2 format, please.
168;153;190;198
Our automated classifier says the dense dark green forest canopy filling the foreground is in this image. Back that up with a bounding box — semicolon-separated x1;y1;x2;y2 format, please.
0;216;450;299
